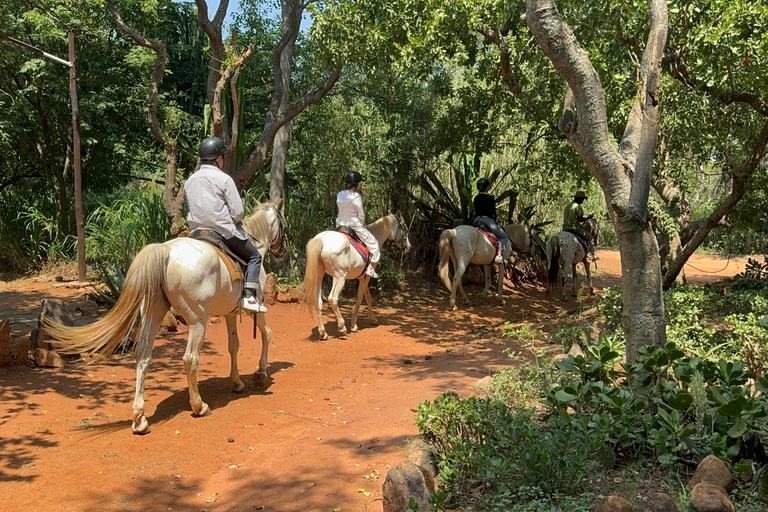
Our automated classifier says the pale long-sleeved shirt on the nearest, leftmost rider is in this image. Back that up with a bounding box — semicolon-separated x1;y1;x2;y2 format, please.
184;164;248;240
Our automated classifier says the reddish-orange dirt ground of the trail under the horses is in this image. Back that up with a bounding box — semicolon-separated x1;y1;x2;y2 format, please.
0;251;747;512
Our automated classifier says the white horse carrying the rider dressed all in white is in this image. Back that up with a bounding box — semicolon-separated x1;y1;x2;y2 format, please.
304;211;411;340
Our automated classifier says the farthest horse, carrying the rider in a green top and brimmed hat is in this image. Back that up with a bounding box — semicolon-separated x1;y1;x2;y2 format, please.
546;219;598;301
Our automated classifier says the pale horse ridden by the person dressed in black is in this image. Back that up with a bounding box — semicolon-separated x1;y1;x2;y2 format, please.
438;224;531;311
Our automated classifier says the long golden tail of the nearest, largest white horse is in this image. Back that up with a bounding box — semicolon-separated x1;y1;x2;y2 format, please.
43;244;169;361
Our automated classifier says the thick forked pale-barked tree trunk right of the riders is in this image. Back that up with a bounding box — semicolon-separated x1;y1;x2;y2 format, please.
525;0;668;364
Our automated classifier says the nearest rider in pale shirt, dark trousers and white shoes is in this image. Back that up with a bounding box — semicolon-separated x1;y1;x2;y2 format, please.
184;137;267;313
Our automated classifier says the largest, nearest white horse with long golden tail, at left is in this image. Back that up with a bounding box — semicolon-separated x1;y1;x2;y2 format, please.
46;199;287;434
